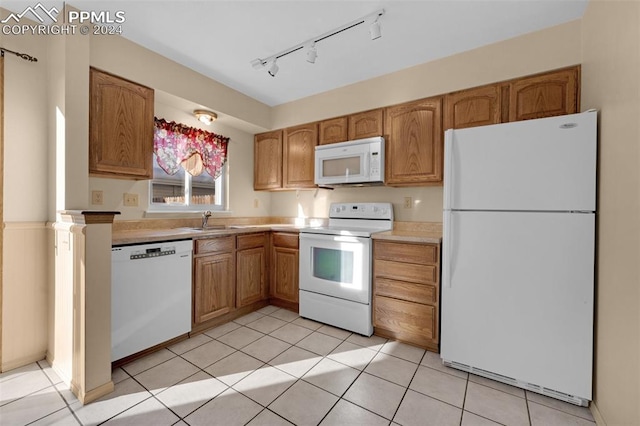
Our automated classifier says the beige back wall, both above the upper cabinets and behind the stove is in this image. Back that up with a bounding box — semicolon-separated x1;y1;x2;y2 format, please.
271;21;581;222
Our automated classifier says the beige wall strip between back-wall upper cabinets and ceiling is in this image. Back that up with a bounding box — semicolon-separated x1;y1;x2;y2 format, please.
272;20;581;128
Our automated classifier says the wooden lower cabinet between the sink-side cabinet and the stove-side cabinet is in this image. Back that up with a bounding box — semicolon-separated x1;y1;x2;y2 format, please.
236;232;267;308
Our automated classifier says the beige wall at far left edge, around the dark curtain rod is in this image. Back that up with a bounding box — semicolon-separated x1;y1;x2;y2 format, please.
0;9;49;371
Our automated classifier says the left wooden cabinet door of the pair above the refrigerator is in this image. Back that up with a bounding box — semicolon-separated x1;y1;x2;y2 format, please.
444;84;502;130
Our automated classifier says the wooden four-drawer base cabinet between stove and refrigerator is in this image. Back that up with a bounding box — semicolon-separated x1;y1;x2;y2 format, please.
373;240;440;352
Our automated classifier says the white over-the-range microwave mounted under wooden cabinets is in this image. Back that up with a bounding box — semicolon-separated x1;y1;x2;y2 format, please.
315;136;384;186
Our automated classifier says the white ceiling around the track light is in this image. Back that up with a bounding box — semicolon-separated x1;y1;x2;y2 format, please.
2;0;588;106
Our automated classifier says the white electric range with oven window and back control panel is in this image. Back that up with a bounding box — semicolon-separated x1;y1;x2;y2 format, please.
299;203;393;336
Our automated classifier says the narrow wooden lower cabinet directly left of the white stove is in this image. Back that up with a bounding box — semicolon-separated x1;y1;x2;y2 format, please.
270;232;299;311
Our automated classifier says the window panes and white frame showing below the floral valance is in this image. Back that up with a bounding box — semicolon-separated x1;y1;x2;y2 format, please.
149;154;225;211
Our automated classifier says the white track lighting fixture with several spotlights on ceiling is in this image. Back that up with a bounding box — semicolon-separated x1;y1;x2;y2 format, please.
251;9;384;77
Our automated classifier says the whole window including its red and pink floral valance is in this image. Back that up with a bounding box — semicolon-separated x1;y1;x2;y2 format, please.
149;118;229;211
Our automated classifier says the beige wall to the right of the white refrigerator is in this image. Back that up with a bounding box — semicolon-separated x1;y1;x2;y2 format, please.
582;0;640;425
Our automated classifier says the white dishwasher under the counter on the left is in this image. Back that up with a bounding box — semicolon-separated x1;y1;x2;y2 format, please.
111;240;193;361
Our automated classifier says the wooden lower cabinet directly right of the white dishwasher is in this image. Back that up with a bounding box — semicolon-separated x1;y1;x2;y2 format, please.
193;236;236;324
